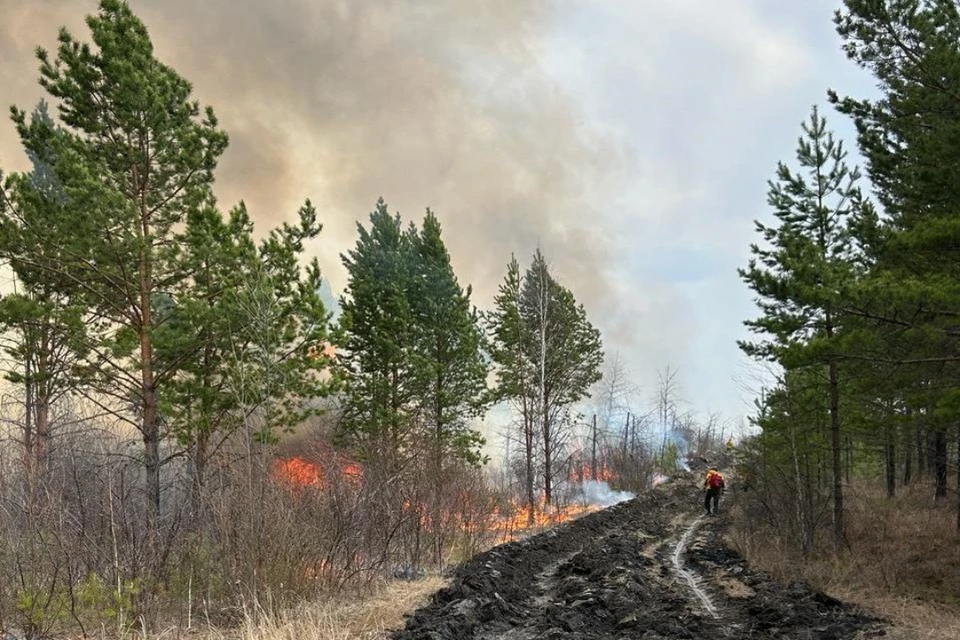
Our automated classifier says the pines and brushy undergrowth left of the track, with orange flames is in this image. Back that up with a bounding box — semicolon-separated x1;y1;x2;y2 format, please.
0;0;603;638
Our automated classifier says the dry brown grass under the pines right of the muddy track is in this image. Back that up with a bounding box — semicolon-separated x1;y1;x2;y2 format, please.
733;483;960;640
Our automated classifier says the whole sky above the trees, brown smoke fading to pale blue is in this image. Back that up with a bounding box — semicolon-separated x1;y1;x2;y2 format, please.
0;0;873;436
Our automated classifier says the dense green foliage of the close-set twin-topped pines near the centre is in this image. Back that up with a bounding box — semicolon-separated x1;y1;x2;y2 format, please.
341;199;487;465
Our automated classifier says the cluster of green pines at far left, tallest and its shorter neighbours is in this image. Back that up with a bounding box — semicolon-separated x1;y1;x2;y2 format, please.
0;0;334;523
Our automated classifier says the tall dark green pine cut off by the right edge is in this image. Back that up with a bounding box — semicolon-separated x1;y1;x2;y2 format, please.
831;0;960;516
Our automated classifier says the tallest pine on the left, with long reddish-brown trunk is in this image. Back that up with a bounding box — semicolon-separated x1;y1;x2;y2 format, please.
5;0;227;541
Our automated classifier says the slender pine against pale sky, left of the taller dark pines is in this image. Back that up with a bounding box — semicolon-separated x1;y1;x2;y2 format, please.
739;107;862;546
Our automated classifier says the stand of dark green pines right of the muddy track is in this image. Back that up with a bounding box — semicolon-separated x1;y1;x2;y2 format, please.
740;0;960;553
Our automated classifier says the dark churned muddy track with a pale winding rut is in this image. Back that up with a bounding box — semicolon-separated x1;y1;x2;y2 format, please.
393;485;884;640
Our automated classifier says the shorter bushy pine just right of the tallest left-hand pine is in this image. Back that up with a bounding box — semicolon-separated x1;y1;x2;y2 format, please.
155;202;335;515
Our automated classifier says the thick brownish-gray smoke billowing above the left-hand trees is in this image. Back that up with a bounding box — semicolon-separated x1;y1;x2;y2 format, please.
0;0;626;313
